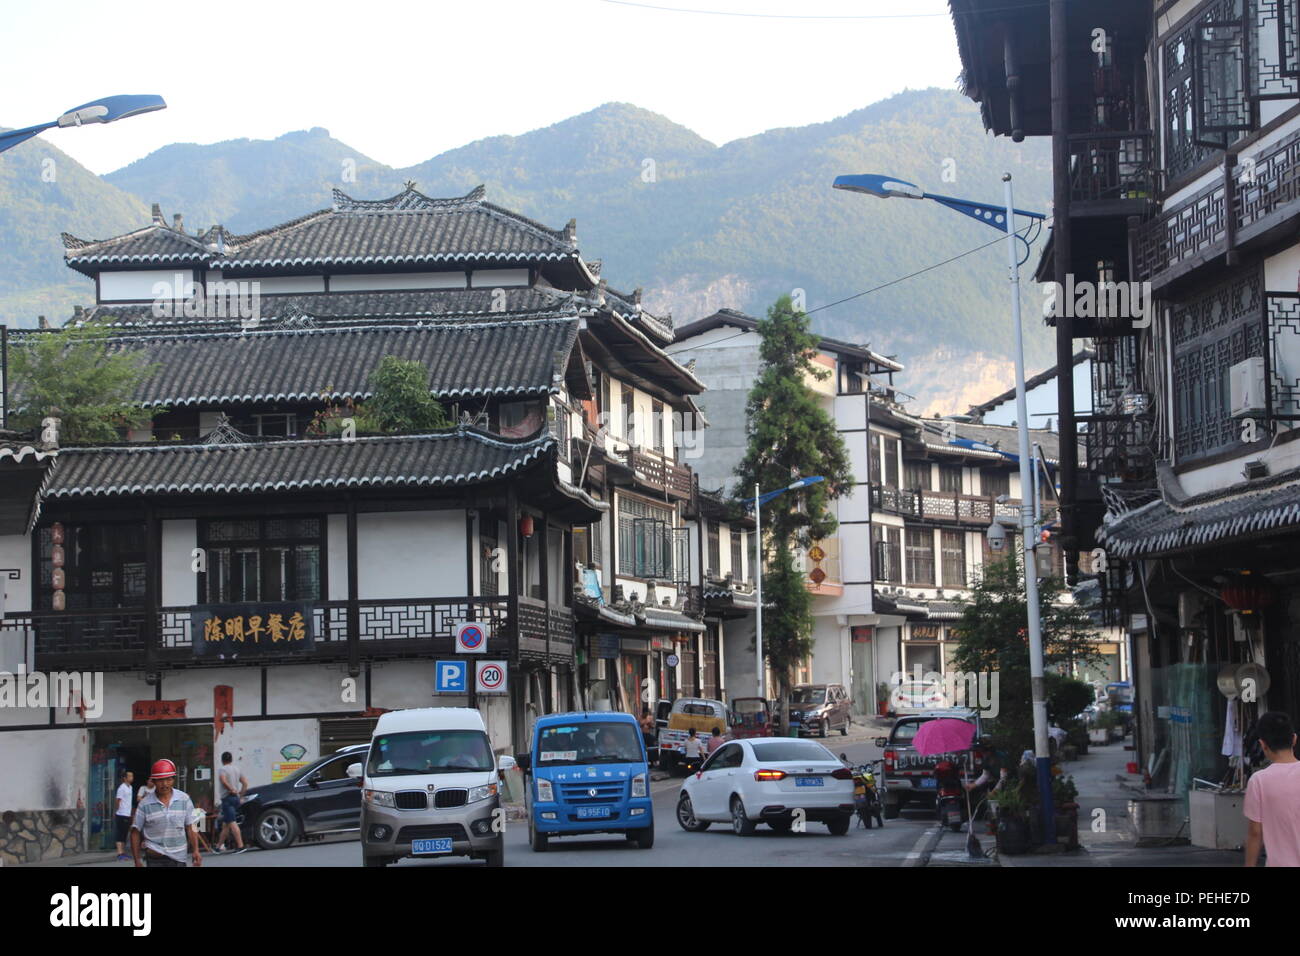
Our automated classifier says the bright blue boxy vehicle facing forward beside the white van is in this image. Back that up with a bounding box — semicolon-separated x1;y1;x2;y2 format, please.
516;711;654;853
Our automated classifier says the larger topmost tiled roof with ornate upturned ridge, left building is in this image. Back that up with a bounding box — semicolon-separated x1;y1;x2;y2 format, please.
213;186;577;268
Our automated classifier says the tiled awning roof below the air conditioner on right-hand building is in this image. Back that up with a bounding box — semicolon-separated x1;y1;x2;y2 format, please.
1097;470;1300;558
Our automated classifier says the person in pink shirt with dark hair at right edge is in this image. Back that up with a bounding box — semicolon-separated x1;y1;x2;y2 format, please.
1242;710;1300;866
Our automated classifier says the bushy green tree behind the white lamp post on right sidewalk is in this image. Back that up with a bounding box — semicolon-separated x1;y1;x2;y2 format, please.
950;555;1101;754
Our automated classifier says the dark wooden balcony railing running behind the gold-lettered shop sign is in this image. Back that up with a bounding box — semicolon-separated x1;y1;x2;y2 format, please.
4;596;575;671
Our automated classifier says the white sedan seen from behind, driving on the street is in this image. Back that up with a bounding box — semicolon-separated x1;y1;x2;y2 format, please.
677;737;854;836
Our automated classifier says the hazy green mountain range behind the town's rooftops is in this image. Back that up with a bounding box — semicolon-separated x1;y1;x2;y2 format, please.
0;88;1053;412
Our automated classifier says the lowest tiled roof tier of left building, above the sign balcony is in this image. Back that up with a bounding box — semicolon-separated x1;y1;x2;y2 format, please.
43;428;555;498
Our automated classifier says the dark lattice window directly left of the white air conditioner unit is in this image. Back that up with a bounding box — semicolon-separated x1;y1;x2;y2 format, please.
1173;268;1265;462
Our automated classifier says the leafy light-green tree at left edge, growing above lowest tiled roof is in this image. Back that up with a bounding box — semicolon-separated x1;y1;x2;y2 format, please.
9;325;157;442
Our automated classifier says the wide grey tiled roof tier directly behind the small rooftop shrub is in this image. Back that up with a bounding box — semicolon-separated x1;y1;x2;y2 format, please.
24;319;579;407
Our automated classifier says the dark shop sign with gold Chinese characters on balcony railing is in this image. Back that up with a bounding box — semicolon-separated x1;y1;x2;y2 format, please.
190;604;315;661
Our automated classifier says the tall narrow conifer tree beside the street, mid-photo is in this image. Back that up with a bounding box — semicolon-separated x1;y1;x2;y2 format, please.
736;295;853;719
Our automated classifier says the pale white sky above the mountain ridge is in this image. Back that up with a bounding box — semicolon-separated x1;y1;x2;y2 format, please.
0;0;961;173
